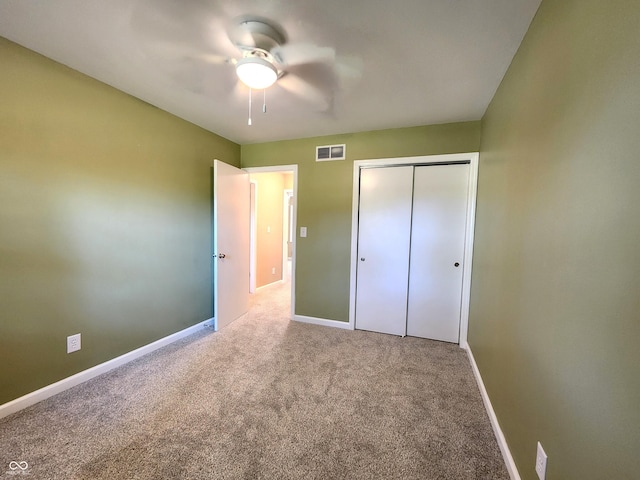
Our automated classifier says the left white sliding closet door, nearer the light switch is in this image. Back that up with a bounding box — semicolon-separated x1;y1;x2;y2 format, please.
356;166;413;335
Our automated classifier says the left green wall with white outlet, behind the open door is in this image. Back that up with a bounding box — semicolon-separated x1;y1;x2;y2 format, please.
0;38;240;404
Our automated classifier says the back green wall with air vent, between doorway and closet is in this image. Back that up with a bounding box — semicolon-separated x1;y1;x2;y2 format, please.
242;122;480;322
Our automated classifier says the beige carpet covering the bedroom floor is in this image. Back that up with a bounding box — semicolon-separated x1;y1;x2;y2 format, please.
0;285;509;480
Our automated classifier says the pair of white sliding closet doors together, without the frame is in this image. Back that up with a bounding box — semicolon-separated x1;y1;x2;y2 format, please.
355;161;470;343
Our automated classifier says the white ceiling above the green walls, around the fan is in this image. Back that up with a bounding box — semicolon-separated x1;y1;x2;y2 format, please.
0;0;540;144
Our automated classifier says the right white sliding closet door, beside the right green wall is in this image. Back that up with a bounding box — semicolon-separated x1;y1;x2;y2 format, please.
407;164;469;343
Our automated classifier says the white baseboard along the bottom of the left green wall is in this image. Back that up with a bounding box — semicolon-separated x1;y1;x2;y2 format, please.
0;318;214;418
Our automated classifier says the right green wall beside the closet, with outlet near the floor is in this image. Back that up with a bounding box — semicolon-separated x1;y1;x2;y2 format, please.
469;0;640;480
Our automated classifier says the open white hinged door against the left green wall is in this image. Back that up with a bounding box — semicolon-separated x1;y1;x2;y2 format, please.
213;160;250;330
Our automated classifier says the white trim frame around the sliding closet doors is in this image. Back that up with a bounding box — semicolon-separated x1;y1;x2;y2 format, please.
349;152;480;348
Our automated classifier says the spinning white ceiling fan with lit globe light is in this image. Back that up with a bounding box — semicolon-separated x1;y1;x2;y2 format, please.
131;7;362;114
